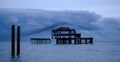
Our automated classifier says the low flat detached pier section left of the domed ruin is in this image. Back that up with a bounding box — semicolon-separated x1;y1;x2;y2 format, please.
30;38;51;44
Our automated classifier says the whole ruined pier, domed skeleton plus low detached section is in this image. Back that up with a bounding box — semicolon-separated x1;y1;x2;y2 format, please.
30;27;93;44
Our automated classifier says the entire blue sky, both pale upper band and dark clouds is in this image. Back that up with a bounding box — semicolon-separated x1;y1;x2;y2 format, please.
0;0;120;41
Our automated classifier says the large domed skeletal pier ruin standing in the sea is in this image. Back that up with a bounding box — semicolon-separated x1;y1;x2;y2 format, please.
52;27;93;44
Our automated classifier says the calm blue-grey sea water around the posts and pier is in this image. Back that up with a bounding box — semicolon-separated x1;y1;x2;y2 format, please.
0;42;120;62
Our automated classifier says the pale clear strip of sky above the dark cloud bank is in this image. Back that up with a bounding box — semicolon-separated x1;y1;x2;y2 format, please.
0;0;120;18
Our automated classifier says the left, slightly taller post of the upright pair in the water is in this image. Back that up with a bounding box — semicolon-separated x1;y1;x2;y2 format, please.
11;25;15;57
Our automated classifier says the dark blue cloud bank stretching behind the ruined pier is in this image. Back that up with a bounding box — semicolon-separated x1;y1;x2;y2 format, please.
0;9;120;41
